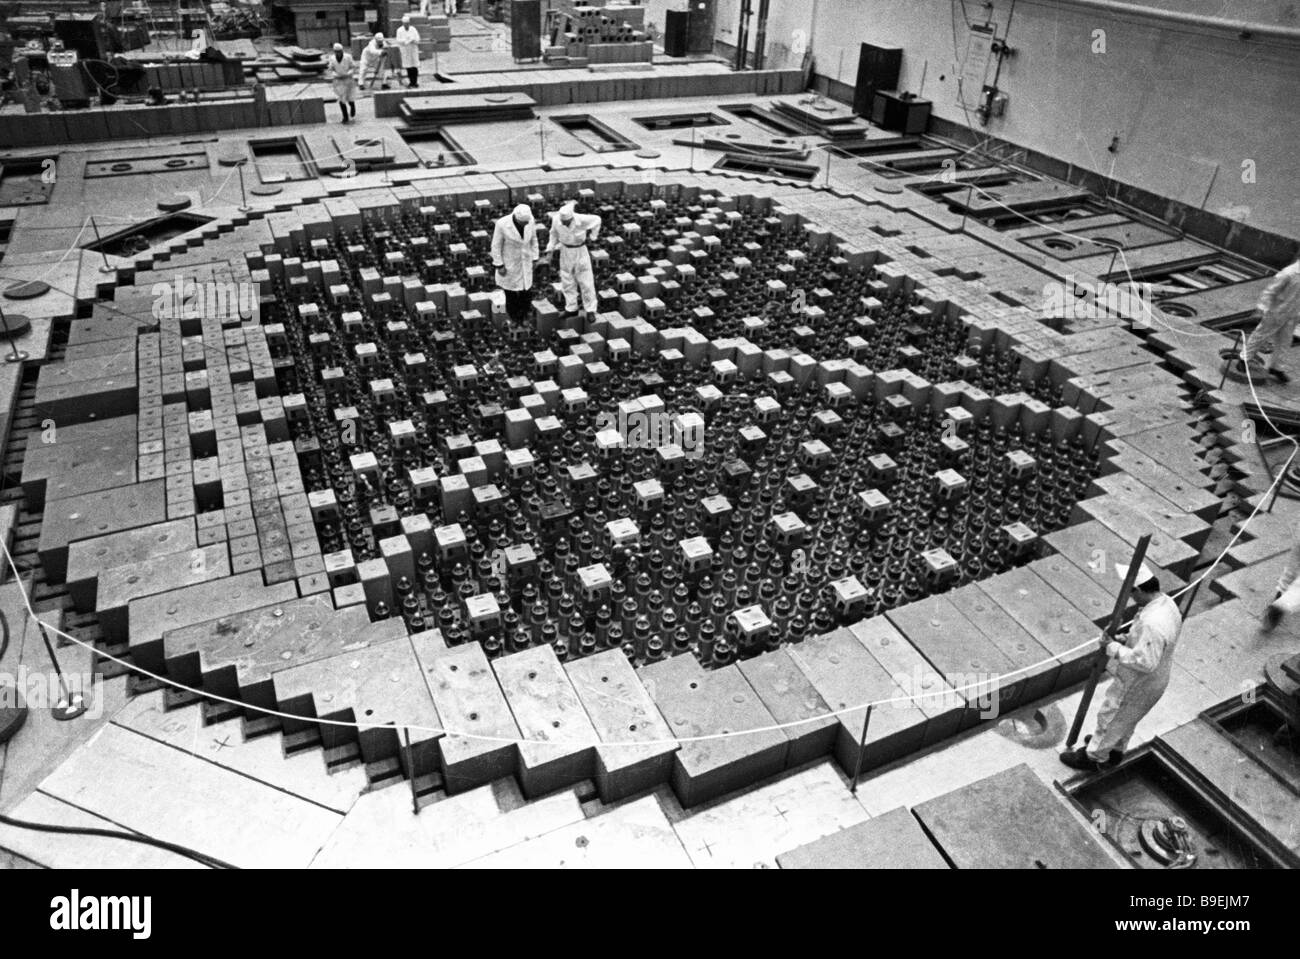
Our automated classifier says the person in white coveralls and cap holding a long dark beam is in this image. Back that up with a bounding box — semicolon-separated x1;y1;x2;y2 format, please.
1061;563;1183;772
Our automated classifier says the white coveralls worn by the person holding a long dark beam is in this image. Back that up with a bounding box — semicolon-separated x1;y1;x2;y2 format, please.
1088;593;1183;763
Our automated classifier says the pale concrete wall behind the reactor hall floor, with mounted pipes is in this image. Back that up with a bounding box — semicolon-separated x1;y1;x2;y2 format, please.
718;0;1300;238
